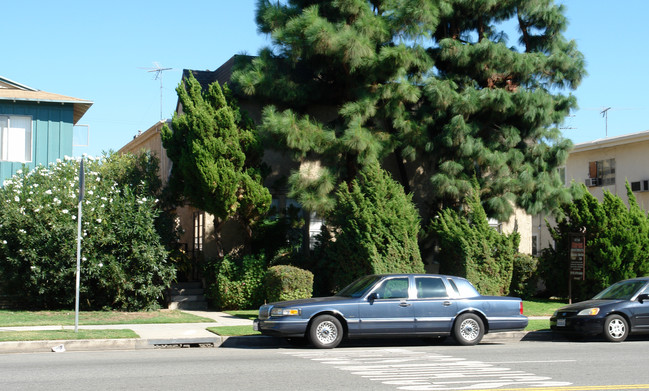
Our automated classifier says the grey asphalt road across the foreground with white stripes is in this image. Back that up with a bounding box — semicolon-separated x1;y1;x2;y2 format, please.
0;338;649;391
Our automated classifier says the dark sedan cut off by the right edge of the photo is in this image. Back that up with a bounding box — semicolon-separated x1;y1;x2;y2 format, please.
550;277;649;342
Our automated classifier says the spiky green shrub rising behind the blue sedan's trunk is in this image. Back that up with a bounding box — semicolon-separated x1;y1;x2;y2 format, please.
431;190;520;295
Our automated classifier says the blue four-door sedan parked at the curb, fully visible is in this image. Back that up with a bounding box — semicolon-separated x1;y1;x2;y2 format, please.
253;274;527;348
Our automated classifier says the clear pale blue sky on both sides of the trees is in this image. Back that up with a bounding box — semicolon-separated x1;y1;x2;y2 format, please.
0;0;649;156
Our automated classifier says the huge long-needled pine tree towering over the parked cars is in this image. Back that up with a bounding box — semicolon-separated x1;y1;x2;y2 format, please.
233;0;584;219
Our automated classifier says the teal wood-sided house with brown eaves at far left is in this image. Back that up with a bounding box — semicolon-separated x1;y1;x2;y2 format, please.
0;76;93;186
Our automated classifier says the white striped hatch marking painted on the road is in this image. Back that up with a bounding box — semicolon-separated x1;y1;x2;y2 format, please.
285;348;574;391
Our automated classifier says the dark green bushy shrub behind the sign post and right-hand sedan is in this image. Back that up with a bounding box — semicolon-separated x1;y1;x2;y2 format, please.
539;182;649;299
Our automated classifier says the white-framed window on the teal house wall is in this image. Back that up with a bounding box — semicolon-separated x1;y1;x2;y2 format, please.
0;115;32;163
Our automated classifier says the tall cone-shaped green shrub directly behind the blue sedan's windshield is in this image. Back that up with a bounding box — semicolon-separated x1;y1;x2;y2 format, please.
316;165;424;292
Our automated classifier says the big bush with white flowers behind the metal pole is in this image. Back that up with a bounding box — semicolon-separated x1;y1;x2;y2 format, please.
0;154;175;310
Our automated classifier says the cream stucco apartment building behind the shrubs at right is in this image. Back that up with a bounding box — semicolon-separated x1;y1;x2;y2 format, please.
532;130;649;254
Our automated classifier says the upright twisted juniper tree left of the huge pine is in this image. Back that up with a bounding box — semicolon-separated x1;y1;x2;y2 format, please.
162;74;271;255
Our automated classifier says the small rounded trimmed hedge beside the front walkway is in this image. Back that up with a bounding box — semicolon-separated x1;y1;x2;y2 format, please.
264;265;313;303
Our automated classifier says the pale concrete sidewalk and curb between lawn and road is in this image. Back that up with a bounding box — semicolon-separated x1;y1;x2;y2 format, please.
0;310;554;354
